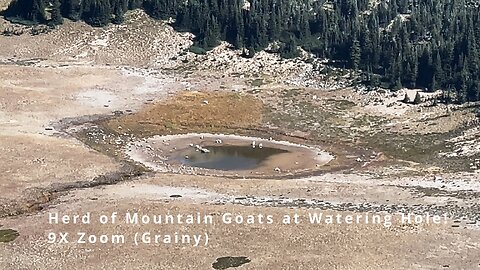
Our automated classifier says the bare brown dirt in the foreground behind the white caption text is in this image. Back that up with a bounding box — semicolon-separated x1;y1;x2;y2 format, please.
0;176;479;270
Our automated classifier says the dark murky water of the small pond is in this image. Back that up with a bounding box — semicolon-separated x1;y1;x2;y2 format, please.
175;145;288;171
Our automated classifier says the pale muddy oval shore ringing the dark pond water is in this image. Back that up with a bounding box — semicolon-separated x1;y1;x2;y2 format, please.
126;133;334;177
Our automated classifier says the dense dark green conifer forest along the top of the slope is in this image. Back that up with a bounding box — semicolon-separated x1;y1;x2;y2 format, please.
4;0;480;103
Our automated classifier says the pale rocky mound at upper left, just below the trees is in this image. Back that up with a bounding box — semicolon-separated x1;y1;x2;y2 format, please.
0;10;191;67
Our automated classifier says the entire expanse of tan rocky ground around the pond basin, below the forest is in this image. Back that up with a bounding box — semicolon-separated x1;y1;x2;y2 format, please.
0;11;480;269
